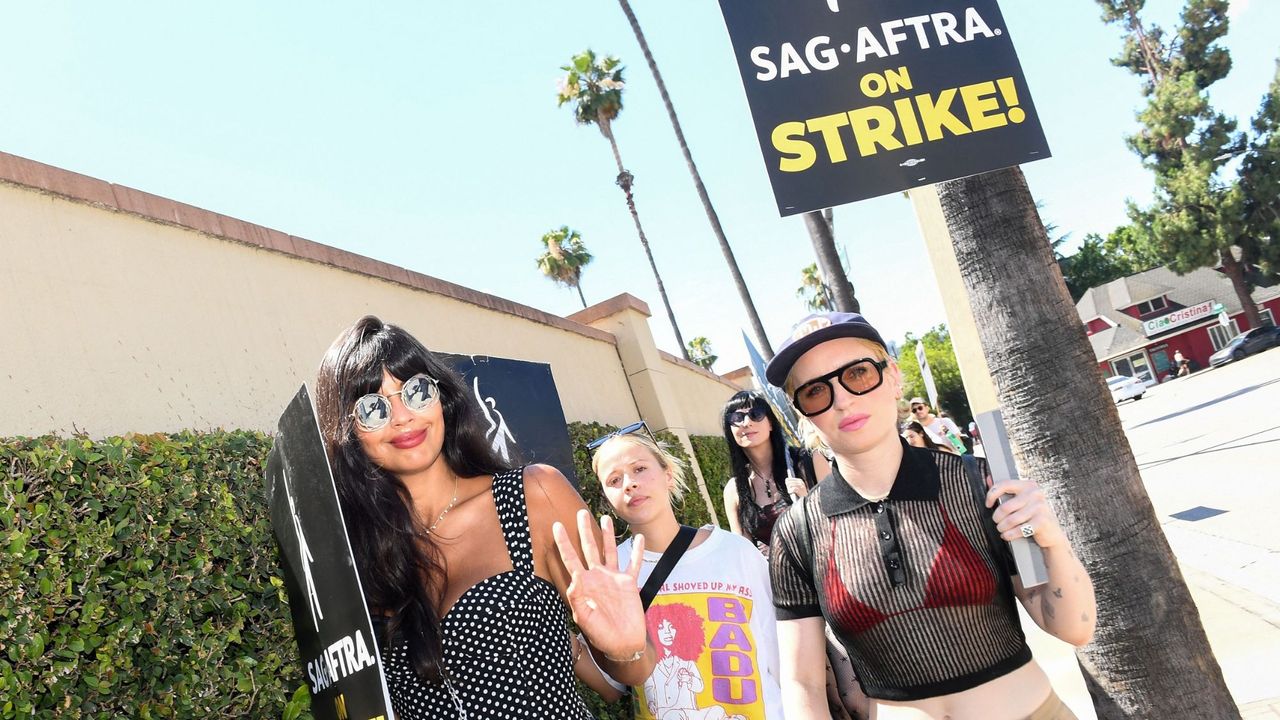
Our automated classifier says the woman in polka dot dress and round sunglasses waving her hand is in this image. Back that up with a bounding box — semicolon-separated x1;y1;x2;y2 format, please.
316;316;654;720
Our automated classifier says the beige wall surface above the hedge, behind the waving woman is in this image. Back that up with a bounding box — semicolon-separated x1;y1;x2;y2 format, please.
0;181;637;437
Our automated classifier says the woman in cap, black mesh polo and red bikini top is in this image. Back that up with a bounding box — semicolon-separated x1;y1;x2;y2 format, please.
767;313;1096;720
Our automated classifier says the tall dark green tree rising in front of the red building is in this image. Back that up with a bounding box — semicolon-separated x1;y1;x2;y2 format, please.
1097;0;1280;327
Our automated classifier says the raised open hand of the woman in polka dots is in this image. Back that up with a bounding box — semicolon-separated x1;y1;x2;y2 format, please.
552;510;648;659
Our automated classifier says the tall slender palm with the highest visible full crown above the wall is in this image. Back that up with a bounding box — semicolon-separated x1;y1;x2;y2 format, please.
558;50;689;360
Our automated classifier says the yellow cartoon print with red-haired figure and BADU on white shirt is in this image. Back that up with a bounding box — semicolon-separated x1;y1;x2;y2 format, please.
636;593;763;720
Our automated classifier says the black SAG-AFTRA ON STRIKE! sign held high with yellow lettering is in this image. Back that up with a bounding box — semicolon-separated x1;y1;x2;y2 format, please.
721;0;1049;215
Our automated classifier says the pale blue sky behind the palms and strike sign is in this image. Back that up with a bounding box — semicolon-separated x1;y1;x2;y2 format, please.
0;0;1280;372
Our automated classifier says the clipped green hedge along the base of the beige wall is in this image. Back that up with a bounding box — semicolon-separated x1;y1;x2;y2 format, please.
0;423;728;720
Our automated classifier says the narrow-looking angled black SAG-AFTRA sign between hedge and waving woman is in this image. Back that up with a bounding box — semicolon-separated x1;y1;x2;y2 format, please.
266;386;390;720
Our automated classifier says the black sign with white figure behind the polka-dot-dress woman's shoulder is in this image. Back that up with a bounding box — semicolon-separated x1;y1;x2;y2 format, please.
435;352;577;487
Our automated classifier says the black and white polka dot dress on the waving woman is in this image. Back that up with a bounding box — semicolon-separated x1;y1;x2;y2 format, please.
373;468;591;720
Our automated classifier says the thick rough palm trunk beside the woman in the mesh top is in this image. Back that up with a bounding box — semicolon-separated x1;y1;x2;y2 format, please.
938;168;1239;720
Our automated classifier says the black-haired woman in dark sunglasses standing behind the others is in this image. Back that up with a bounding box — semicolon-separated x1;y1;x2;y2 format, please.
722;391;826;550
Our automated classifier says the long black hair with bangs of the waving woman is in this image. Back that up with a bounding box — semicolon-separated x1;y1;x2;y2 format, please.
316;315;509;682
